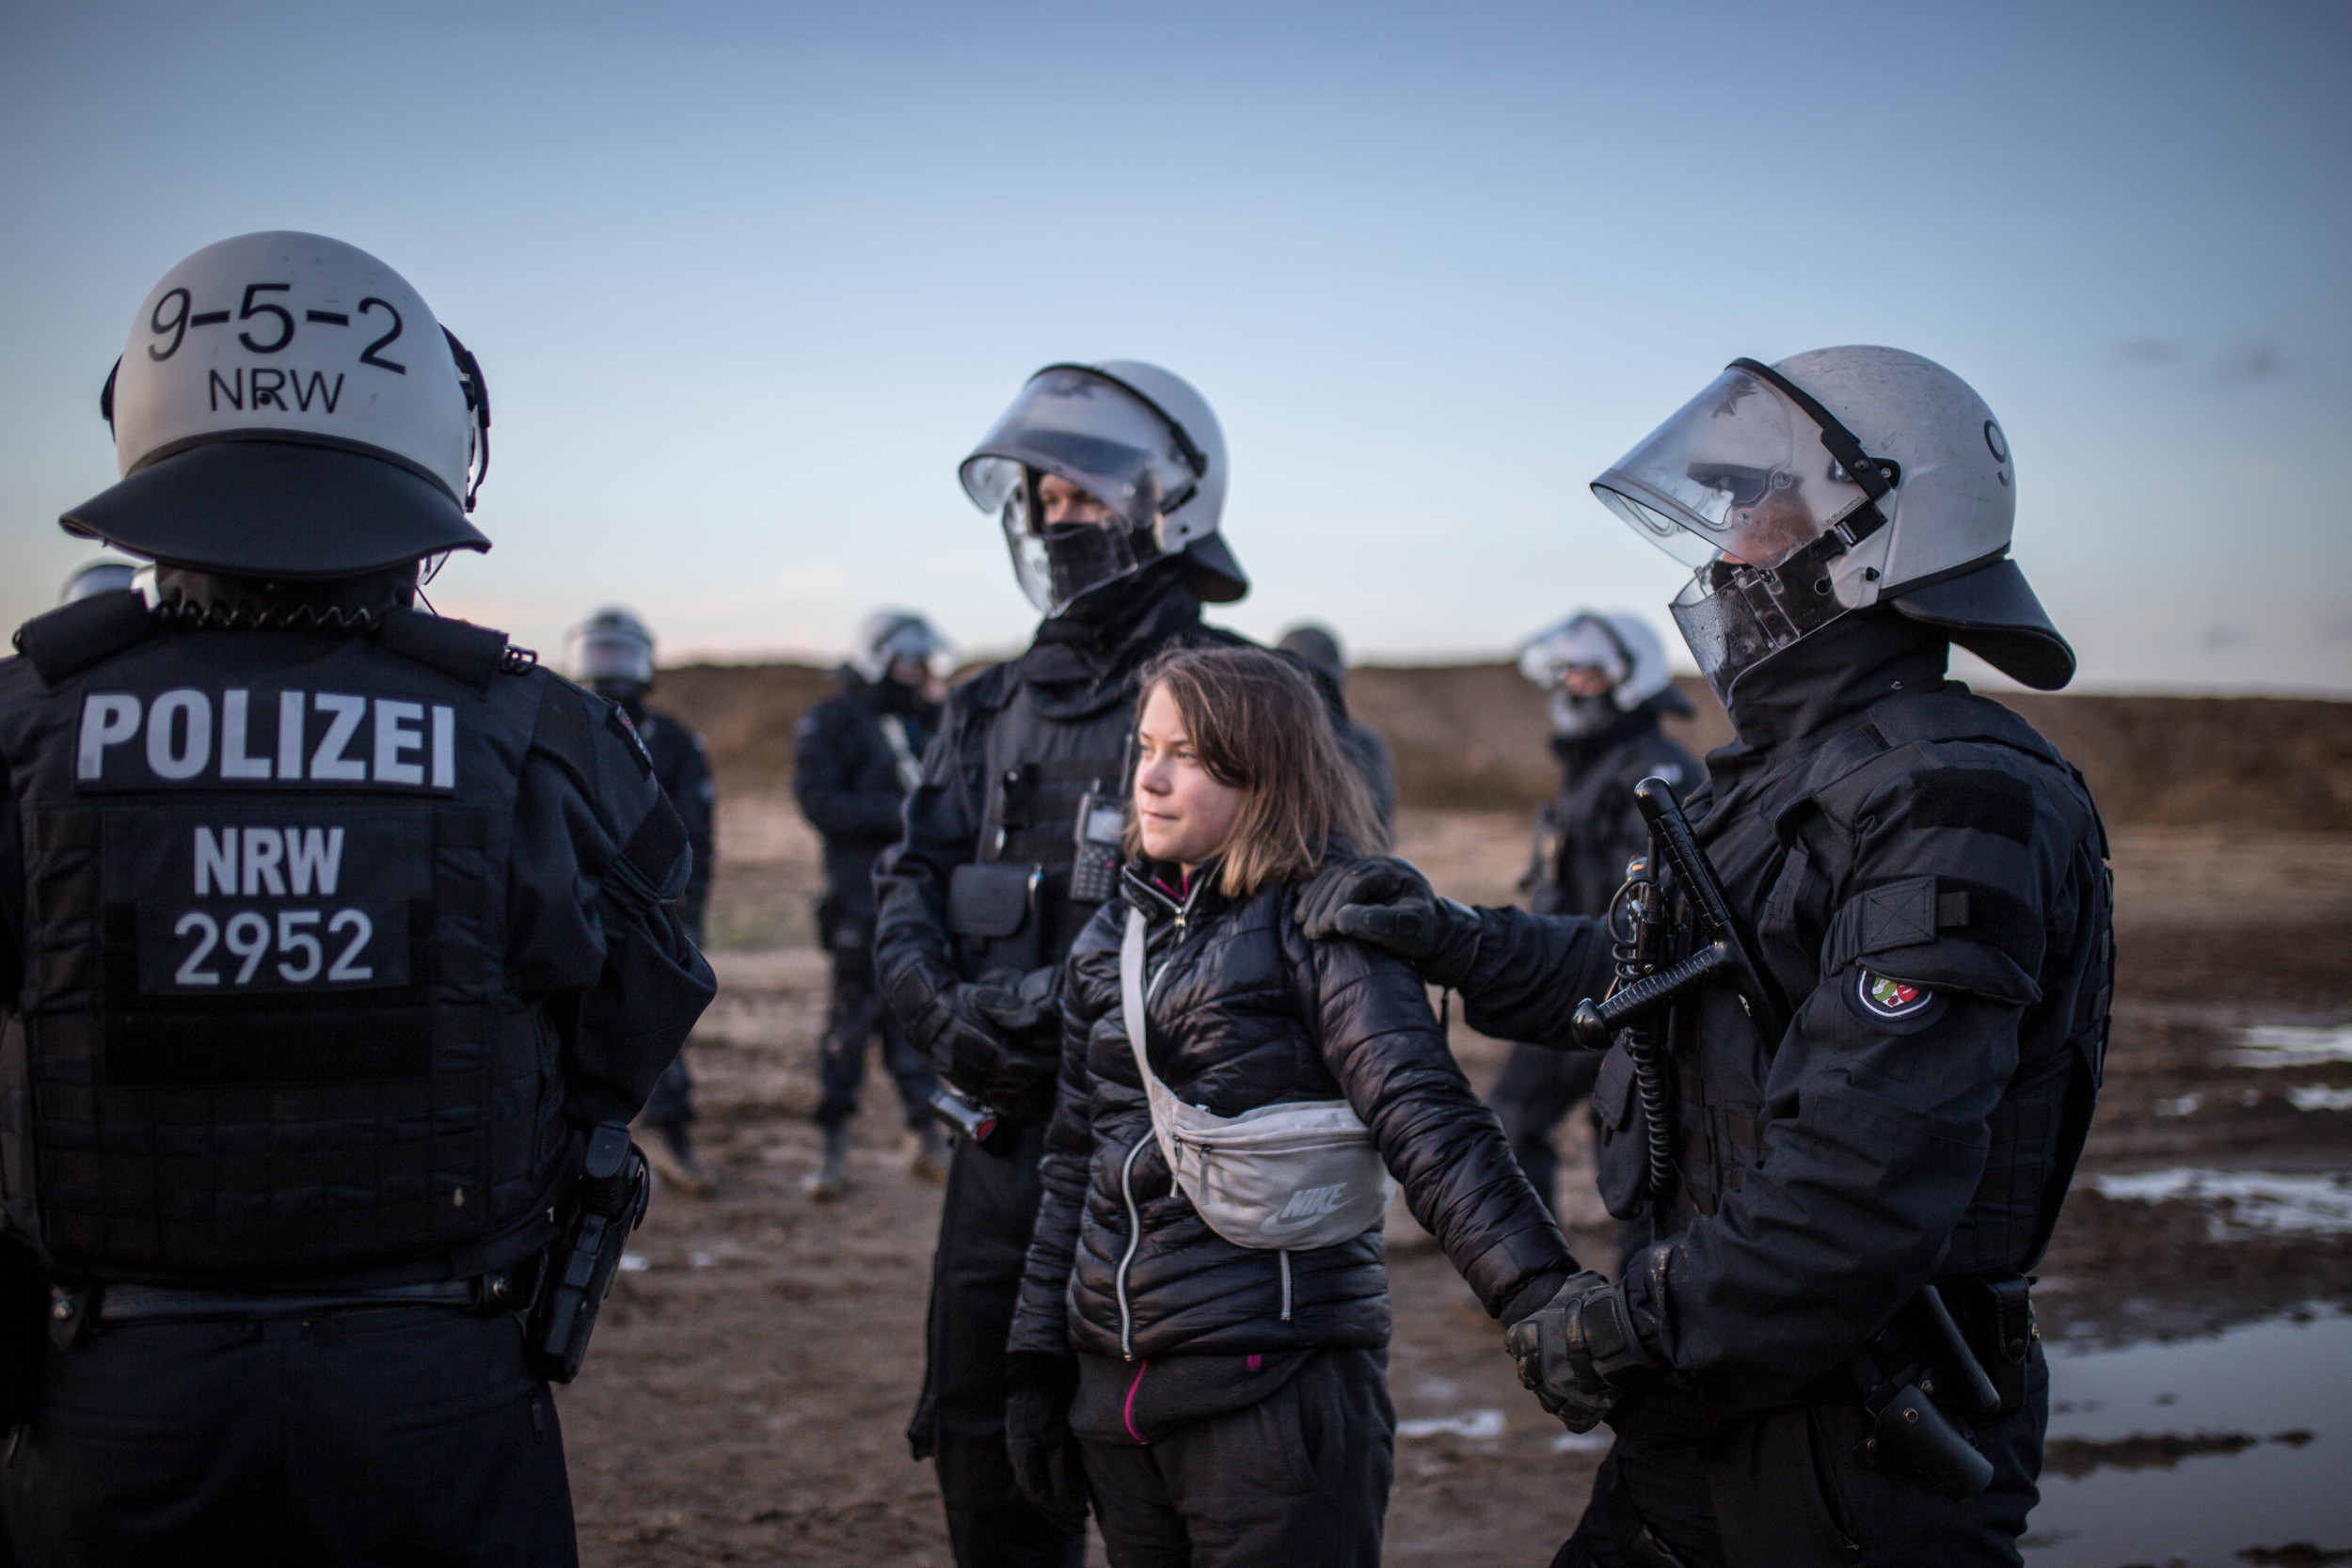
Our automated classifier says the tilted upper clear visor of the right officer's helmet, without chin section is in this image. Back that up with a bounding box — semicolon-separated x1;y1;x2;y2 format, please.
1593;369;1870;566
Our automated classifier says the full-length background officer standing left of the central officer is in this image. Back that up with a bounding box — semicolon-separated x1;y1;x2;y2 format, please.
793;609;948;1201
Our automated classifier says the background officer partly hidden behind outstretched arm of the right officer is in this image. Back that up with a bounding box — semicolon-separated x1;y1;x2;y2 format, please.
1489;609;1698;1206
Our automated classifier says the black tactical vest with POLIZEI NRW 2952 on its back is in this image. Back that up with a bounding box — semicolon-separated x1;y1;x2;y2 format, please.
0;594;564;1284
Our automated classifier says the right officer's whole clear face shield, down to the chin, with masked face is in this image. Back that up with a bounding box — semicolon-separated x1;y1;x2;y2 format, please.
1593;359;1900;703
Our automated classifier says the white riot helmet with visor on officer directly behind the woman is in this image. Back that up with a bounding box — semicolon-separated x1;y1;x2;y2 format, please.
958;359;1249;616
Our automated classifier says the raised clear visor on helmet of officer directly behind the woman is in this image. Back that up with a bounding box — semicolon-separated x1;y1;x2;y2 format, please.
960;364;1200;529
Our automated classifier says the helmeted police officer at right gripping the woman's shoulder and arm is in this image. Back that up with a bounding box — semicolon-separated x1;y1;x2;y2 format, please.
1303;348;2115;1568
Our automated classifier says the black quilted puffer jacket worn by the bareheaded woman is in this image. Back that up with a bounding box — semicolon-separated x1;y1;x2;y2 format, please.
1009;865;1576;1359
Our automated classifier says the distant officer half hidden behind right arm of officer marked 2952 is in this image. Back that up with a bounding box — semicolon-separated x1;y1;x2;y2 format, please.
572;604;720;1199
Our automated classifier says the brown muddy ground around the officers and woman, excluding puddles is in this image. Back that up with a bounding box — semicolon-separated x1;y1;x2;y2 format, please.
560;795;2352;1568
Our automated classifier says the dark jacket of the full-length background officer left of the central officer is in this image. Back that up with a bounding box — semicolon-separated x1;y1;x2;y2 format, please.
793;668;939;922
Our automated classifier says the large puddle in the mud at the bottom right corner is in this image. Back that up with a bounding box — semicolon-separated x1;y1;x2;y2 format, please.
2021;1317;2352;1568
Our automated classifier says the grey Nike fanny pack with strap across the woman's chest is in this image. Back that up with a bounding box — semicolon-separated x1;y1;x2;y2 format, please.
1120;908;1397;1253
